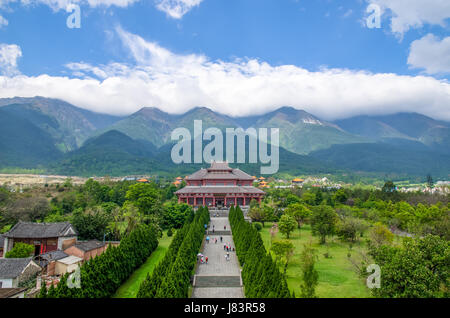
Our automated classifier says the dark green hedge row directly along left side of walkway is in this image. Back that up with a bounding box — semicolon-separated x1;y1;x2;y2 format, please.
137;207;209;298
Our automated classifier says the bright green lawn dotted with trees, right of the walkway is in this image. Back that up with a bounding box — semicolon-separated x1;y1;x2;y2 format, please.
261;223;370;298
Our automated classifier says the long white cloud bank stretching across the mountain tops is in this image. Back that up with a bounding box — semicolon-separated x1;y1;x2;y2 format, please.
0;28;450;120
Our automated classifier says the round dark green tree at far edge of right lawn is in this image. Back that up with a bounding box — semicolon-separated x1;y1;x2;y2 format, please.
311;205;337;244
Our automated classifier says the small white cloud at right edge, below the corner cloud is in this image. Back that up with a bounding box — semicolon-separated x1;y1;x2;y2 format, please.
408;34;450;74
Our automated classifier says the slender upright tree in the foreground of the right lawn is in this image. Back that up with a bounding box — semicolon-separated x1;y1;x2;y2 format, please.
300;244;319;298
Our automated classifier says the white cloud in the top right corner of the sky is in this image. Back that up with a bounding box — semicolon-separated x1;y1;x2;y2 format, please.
367;0;450;35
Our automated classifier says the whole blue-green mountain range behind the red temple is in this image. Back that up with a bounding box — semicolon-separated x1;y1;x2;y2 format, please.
0;97;450;178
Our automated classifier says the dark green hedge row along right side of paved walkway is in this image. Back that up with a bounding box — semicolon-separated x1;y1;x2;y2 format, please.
229;206;292;298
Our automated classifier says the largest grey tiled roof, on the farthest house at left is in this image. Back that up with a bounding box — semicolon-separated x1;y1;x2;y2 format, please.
4;221;76;238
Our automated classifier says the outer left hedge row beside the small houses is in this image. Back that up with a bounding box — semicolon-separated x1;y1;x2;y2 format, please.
39;224;158;298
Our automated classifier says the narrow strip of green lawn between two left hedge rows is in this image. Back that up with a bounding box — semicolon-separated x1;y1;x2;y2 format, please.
113;233;173;298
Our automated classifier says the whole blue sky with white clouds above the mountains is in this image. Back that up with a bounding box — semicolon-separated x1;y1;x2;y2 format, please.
0;0;450;120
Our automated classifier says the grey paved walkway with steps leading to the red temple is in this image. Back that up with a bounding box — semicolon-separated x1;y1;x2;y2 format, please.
192;216;244;298
